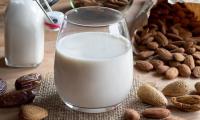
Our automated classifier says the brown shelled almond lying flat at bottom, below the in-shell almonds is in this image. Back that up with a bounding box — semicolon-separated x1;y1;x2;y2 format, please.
142;108;171;119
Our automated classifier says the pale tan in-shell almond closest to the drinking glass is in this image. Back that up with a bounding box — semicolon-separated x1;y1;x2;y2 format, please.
137;84;168;106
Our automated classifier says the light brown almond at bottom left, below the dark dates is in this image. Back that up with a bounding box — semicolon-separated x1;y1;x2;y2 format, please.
19;105;48;120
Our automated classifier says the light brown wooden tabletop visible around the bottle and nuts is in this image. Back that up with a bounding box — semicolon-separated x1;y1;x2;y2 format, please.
0;0;200;120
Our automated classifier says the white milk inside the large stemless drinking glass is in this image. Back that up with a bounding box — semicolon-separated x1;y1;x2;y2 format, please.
55;32;133;108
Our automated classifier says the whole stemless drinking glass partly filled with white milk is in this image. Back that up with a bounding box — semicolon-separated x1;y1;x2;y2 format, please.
54;6;133;113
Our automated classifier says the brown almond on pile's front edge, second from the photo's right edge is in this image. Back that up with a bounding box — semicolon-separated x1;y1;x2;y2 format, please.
178;64;192;77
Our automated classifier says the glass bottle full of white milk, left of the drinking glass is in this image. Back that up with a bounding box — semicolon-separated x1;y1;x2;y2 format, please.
5;0;44;67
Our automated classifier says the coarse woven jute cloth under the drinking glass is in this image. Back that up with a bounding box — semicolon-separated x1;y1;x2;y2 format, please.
34;73;148;120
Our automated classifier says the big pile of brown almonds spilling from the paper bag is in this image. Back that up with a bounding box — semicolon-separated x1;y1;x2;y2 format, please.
134;1;200;79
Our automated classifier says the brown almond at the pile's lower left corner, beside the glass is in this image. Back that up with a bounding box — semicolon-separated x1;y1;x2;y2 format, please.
135;60;153;72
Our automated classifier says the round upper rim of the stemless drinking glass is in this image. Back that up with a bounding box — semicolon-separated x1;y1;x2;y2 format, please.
64;6;125;27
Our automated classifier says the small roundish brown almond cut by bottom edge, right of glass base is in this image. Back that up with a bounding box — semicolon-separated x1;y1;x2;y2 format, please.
124;109;140;120
